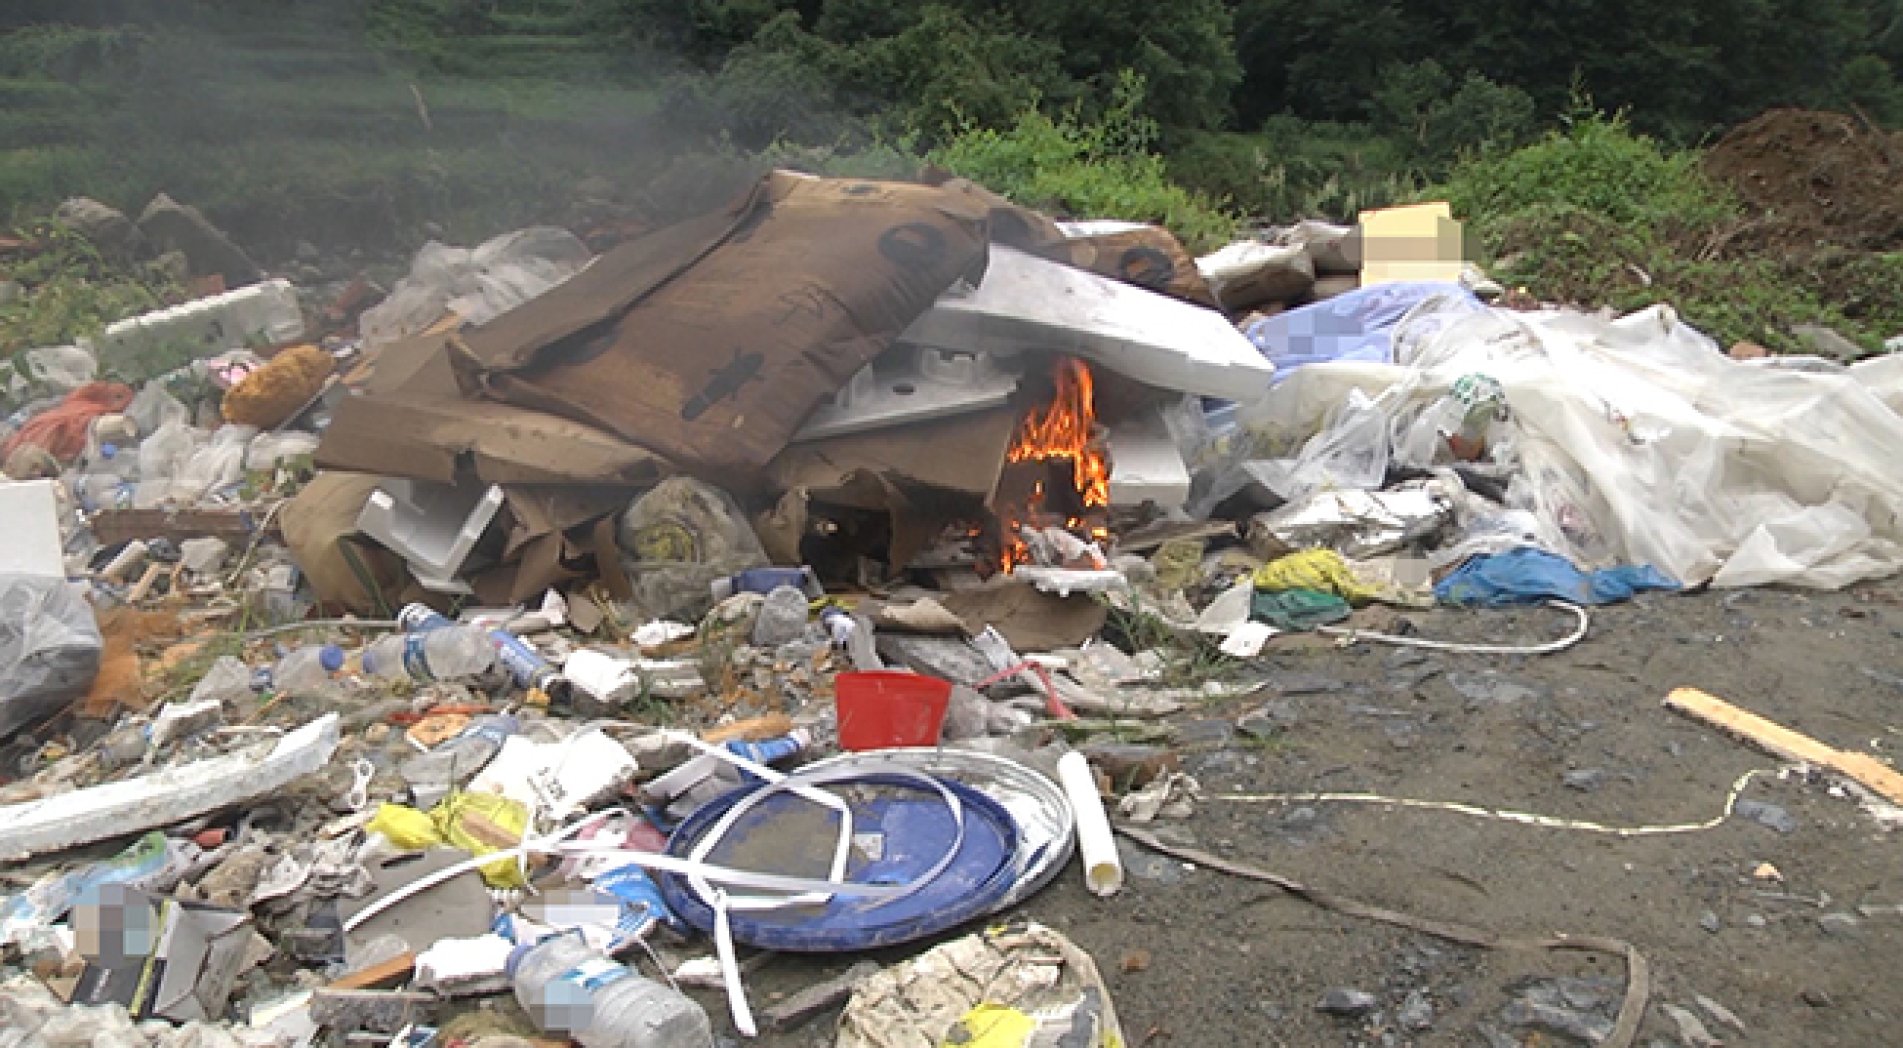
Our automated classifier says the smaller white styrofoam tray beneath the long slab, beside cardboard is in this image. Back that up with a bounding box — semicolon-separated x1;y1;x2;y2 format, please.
794;346;1018;441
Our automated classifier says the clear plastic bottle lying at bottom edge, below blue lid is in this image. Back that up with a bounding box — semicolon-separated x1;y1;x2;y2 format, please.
506;936;714;1048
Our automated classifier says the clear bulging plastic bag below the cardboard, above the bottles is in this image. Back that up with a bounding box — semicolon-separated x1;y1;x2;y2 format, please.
615;477;767;620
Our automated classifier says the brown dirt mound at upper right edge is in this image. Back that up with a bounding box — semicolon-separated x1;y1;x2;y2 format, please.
1705;108;1903;251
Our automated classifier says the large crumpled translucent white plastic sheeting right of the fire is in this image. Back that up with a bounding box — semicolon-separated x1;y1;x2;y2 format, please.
1231;306;1903;590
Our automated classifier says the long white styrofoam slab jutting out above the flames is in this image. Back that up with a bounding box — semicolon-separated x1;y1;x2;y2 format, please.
898;243;1275;401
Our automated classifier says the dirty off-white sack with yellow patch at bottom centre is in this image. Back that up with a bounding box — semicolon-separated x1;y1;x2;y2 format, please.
834;922;1127;1048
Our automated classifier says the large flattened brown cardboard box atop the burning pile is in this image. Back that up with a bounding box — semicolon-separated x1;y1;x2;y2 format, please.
451;171;990;475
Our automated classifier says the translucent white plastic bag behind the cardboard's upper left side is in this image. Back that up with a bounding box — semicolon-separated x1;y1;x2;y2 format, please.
358;226;592;346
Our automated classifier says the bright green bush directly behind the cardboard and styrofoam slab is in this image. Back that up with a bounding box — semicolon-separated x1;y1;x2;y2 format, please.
927;74;1237;251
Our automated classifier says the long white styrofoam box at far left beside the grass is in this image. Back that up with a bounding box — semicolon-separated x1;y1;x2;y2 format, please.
93;280;304;376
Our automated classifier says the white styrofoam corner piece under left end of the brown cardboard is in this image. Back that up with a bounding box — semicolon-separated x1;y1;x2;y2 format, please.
358;479;502;593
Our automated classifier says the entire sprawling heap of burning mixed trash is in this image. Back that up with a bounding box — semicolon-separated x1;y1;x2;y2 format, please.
0;171;1903;1046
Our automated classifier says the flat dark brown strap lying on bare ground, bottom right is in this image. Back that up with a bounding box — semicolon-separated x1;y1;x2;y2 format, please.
1115;824;1652;1048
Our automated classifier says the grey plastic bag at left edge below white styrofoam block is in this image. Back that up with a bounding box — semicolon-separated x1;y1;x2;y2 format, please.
0;574;103;740
